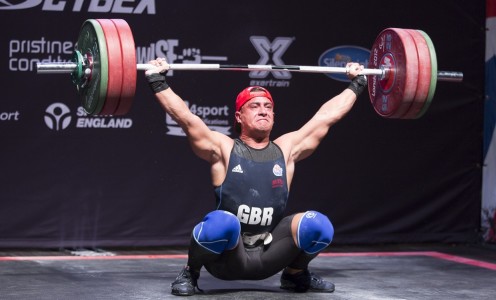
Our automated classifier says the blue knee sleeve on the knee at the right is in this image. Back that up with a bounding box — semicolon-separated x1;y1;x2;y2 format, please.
296;211;334;254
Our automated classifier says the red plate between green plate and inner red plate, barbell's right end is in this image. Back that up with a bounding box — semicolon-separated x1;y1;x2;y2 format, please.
401;29;432;119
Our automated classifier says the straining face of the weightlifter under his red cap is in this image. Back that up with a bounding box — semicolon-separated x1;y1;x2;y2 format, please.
236;97;274;132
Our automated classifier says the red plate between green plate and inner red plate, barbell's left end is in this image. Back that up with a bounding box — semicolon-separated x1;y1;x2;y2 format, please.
97;19;122;115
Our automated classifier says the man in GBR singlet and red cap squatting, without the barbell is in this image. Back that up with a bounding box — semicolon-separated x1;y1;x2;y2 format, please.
145;58;367;296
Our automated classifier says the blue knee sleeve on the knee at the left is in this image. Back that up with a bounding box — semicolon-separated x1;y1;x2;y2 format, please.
193;210;241;254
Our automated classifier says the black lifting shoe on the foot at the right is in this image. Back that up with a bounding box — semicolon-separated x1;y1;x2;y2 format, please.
281;270;334;293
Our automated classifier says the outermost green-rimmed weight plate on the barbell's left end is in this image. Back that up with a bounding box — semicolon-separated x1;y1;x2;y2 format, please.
76;19;108;115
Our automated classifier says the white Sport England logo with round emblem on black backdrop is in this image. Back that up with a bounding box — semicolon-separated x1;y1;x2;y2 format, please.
44;102;133;131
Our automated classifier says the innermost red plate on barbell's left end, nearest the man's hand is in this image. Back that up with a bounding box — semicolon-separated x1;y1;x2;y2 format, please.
111;19;137;115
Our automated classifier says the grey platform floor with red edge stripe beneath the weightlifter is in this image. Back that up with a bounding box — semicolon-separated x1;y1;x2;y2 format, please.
0;245;496;300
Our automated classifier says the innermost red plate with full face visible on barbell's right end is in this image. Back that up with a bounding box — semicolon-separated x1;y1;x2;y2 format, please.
368;28;418;118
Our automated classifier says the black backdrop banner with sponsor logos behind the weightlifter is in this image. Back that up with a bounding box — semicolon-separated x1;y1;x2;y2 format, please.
0;0;485;247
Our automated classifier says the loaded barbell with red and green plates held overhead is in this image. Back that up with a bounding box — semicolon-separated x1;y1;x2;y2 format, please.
37;19;463;119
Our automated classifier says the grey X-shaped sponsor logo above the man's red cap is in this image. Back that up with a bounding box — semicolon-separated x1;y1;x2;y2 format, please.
249;36;294;87
